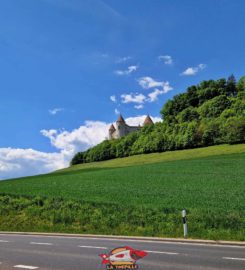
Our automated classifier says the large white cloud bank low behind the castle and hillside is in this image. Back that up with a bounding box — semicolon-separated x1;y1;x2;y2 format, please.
0;115;161;180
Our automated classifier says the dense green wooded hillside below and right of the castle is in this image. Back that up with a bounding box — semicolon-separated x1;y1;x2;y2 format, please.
71;75;245;165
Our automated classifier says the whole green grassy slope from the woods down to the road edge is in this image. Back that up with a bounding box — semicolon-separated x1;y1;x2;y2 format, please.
0;144;245;240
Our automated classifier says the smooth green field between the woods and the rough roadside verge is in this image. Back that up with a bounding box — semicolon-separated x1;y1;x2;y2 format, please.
0;145;245;209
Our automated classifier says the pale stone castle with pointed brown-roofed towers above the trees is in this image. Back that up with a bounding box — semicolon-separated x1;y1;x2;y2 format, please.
109;114;154;140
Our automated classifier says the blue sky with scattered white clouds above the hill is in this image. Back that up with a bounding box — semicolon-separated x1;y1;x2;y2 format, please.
0;0;245;180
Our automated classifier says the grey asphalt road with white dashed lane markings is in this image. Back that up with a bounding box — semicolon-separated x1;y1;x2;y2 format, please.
0;234;245;270
